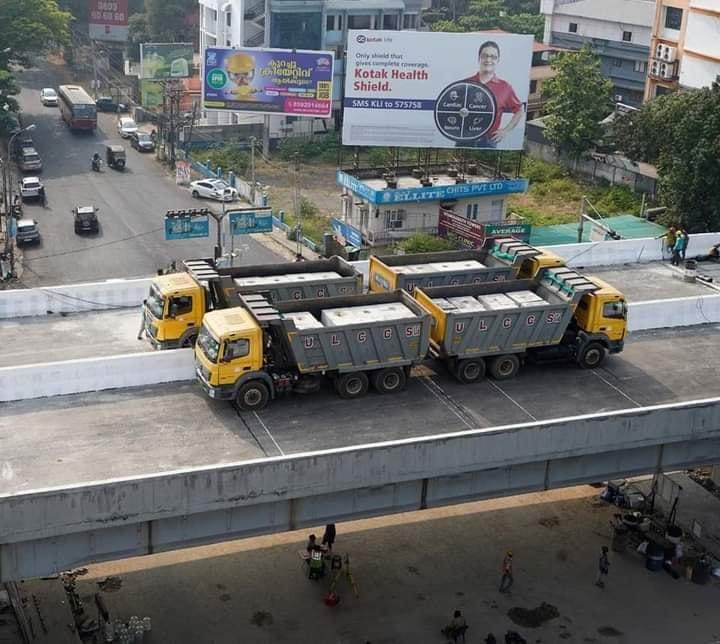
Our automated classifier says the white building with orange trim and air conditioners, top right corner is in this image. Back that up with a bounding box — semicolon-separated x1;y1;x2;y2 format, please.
645;0;720;100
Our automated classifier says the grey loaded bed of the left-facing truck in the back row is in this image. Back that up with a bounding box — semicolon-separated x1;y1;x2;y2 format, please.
184;257;363;306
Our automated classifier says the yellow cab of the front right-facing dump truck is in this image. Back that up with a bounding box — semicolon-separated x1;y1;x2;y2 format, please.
575;277;628;353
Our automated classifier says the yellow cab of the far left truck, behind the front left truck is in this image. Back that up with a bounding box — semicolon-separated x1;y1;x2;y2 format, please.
143;273;207;349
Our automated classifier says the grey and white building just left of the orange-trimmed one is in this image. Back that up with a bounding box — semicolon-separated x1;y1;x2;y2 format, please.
540;0;656;105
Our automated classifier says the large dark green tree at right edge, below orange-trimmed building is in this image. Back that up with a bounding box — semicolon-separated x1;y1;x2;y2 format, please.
613;83;720;232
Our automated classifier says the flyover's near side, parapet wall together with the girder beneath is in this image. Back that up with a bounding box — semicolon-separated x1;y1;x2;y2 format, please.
0;398;720;581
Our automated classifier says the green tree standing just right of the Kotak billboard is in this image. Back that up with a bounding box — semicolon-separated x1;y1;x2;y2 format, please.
543;47;612;159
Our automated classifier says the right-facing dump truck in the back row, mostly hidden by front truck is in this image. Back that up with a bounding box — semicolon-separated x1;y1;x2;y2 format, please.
368;238;565;293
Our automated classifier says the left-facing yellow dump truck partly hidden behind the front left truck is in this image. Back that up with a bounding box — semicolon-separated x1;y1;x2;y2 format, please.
142;257;363;349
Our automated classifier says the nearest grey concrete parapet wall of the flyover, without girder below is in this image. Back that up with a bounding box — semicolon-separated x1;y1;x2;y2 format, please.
0;398;720;544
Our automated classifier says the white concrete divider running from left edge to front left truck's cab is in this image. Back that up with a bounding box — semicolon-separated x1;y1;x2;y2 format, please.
0;349;195;402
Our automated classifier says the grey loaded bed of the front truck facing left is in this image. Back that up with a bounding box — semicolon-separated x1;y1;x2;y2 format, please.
242;291;431;374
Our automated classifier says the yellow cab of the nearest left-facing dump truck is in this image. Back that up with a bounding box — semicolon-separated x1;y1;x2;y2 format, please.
195;307;273;407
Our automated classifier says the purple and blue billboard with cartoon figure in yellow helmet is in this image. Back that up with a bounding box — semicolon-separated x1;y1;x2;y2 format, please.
202;47;333;118
